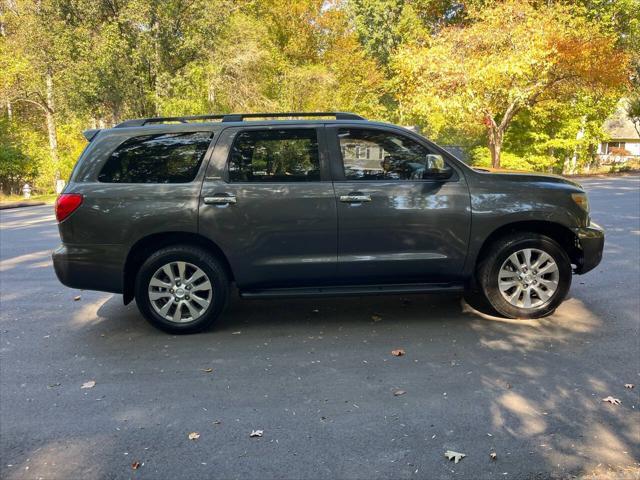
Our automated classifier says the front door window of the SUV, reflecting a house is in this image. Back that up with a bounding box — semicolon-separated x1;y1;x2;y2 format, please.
338;128;450;180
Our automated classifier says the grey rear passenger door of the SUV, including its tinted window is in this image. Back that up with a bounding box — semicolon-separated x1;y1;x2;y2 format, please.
199;124;337;288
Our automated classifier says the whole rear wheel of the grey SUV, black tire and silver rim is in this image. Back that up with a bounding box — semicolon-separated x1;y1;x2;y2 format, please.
135;245;229;333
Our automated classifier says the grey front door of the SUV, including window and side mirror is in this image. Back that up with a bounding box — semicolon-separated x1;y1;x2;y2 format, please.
326;124;471;283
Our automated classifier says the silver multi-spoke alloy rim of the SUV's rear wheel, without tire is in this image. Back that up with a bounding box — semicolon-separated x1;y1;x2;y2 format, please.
148;261;213;323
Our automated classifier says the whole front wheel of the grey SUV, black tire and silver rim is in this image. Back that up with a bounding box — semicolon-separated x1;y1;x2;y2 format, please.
477;233;571;318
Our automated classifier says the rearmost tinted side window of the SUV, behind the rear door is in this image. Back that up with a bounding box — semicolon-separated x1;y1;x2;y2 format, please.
98;132;212;183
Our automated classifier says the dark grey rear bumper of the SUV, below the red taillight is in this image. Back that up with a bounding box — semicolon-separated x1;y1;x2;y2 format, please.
51;244;124;293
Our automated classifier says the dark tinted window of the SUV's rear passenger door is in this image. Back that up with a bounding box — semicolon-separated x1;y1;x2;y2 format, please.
229;129;320;182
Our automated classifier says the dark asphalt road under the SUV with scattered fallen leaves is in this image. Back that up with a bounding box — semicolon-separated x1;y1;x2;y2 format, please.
0;176;640;479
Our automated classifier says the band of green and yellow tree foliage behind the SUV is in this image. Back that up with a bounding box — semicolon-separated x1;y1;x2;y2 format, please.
0;0;640;193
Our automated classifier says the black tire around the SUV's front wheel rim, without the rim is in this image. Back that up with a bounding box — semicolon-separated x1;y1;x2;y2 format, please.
476;233;572;319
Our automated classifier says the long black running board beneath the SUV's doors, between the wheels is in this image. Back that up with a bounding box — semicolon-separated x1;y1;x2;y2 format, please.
240;283;464;298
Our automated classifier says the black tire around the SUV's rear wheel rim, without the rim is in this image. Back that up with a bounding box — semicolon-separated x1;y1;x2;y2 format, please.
135;245;230;334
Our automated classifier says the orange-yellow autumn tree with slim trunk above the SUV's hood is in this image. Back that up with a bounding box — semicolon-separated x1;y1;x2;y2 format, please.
393;0;630;168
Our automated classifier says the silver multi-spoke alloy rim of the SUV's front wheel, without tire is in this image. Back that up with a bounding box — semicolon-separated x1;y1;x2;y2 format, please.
498;248;560;309
